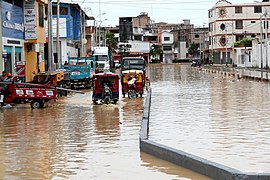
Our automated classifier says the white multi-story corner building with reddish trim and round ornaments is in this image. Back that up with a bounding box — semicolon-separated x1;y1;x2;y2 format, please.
209;0;270;64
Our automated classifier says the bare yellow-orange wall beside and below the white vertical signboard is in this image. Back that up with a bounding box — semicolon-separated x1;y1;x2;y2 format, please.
24;0;48;82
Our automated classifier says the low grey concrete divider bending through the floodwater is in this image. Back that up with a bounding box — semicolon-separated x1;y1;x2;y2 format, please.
140;87;270;180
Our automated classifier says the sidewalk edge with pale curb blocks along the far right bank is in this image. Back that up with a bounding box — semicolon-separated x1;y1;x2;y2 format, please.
201;64;270;82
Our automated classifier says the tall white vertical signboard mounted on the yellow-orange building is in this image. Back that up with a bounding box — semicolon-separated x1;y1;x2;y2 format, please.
24;0;37;40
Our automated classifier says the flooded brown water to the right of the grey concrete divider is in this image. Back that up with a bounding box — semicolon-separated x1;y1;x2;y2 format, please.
149;65;270;172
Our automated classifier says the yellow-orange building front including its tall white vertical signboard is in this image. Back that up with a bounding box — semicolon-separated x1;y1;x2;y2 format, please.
24;0;48;82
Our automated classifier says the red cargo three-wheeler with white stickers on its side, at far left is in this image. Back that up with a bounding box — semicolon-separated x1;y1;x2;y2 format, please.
0;81;57;109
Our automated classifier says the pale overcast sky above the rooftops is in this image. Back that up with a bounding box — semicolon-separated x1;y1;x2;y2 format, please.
58;0;260;26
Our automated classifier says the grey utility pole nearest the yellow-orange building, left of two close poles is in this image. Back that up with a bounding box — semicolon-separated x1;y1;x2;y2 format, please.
47;0;53;71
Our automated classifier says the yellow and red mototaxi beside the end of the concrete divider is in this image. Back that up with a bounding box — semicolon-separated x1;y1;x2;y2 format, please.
121;70;145;99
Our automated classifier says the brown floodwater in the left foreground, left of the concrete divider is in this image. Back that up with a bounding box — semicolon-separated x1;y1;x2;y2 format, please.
0;87;207;180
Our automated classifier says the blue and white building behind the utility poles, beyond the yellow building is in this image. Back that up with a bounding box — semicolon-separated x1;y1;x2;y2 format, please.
52;3;91;67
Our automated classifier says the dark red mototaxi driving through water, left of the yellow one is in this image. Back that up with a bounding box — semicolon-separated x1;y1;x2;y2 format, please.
92;72;119;104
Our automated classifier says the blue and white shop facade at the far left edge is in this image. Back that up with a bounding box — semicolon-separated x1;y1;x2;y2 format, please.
0;0;25;79
